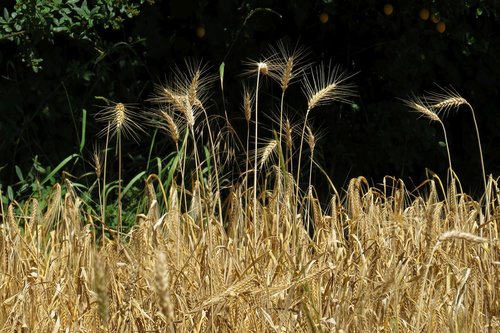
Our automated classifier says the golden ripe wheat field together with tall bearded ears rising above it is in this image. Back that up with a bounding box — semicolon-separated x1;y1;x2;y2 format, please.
0;44;500;333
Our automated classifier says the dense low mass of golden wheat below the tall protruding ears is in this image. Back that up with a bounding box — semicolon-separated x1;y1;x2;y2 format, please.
0;178;500;332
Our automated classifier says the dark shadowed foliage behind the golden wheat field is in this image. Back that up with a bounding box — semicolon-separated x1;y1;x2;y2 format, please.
0;0;500;197
